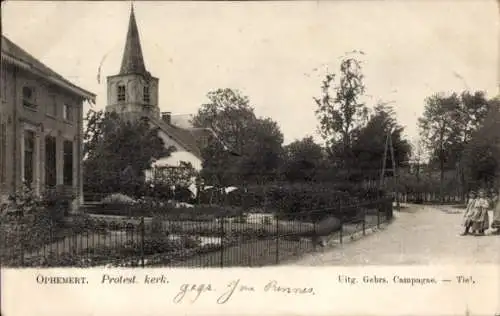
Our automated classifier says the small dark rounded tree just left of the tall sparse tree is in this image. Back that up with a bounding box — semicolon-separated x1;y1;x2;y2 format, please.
283;137;325;181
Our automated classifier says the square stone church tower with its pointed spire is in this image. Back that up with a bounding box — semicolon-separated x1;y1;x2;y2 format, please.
106;6;160;120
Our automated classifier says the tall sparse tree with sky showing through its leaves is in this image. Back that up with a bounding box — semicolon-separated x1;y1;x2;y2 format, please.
314;57;367;156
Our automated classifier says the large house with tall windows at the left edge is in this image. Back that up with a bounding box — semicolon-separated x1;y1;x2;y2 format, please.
0;36;95;207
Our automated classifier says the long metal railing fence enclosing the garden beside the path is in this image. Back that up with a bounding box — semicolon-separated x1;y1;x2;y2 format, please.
1;198;393;267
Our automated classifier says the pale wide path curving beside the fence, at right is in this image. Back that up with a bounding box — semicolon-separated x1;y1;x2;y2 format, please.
291;205;500;266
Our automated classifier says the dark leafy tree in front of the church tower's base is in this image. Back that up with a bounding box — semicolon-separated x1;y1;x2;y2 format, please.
83;110;173;195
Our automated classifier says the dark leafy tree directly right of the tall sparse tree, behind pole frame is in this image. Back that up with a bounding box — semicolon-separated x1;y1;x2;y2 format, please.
351;104;411;179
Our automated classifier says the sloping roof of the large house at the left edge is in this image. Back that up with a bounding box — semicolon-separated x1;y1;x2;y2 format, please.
2;35;95;102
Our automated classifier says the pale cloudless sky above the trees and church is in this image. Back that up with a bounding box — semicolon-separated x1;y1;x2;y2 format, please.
2;0;499;143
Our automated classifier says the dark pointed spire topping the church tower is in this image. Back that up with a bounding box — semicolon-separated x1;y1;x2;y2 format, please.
120;3;147;75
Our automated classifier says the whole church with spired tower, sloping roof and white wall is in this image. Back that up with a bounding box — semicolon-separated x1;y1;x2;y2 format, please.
106;7;211;190
